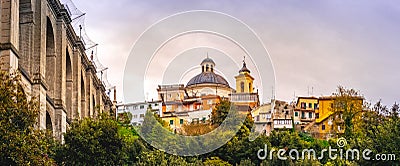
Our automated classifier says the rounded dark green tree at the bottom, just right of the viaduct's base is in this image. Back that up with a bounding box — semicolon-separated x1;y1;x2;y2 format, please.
58;115;127;165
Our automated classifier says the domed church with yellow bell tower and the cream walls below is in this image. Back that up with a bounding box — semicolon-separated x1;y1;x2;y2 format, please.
157;57;259;129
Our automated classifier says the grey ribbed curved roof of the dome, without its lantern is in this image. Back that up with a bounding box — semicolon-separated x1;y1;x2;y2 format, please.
186;72;229;87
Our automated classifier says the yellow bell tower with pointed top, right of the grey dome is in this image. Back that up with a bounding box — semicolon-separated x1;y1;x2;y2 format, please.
235;58;254;93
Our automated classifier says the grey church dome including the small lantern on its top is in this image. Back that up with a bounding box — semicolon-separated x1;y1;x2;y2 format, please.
186;56;229;87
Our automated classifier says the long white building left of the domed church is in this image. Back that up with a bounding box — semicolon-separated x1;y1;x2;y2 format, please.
117;101;162;125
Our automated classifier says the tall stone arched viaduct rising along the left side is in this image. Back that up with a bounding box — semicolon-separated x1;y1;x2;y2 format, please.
0;0;115;140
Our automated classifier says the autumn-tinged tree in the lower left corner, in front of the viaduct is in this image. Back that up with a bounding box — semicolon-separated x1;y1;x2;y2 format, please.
0;71;57;165
